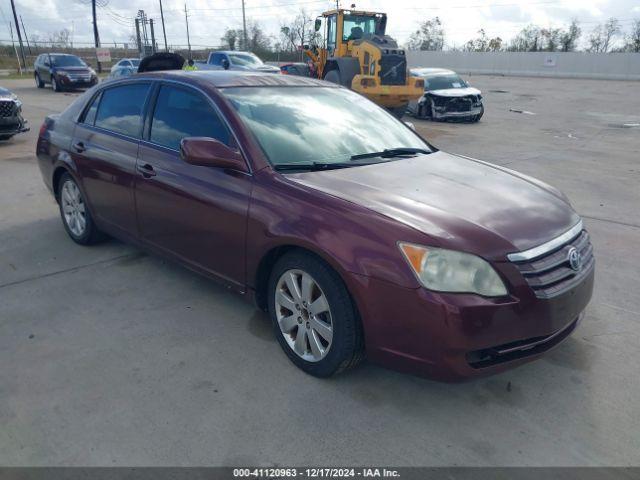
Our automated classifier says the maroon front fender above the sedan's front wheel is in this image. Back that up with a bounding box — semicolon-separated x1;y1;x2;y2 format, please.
246;169;428;288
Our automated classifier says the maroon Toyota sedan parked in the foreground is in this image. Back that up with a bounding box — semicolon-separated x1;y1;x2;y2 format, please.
37;71;594;380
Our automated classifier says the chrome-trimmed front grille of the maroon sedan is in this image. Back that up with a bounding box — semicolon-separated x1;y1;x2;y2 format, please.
514;230;595;298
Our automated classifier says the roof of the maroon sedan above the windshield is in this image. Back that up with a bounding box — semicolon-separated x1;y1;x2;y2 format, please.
136;70;330;88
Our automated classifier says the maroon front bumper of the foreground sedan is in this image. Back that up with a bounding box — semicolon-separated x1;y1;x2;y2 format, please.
347;262;594;381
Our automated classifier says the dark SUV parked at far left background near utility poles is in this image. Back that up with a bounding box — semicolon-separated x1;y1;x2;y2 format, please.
33;53;98;92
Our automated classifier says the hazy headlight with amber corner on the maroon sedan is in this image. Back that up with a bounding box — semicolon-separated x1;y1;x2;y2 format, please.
398;242;507;297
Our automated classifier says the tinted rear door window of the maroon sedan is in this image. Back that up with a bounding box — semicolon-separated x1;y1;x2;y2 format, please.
96;83;149;137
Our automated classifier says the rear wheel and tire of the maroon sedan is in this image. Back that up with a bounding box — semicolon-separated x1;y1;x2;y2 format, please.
58;173;104;245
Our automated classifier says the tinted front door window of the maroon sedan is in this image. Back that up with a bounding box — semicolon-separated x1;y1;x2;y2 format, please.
150;86;229;150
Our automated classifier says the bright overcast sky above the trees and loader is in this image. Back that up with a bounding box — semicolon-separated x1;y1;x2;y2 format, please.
0;0;640;47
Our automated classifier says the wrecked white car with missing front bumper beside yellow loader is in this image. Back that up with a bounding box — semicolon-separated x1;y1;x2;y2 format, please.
407;68;484;122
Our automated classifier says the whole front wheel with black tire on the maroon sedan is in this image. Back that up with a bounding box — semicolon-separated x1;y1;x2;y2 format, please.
268;251;364;377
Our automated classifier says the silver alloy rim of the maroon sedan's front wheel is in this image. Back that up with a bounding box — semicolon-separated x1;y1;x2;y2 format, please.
275;270;333;362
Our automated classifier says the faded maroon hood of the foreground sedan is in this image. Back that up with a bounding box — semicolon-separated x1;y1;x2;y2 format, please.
287;152;579;259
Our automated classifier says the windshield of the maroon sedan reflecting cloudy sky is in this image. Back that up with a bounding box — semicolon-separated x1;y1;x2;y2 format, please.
223;87;431;166
